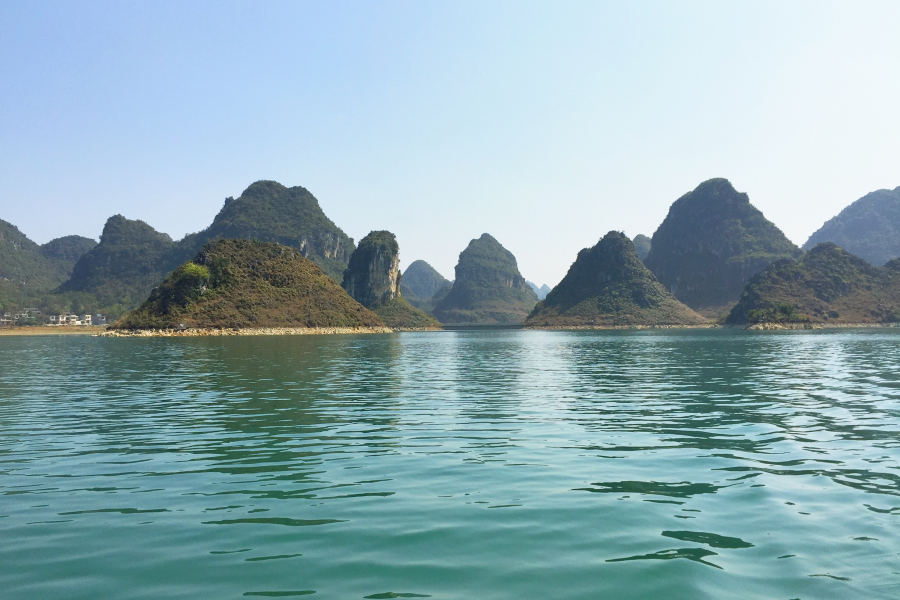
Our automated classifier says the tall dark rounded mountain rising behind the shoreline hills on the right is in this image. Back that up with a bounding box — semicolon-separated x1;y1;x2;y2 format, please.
644;179;802;314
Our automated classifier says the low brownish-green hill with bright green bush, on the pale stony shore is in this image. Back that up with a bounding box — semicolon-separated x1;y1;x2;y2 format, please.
114;240;383;329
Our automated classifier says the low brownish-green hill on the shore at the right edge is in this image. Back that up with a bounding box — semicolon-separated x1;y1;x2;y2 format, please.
726;243;900;325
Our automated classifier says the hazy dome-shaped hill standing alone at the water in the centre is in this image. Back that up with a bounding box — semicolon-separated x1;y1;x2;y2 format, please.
434;233;538;325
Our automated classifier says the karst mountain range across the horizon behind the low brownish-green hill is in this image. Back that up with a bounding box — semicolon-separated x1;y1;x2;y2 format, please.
0;179;900;328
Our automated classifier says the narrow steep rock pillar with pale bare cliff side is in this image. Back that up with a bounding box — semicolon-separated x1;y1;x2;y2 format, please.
341;231;400;310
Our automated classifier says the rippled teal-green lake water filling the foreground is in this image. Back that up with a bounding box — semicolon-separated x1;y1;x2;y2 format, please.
0;330;900;600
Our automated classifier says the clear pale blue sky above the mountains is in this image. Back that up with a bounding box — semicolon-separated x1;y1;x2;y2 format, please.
0;0;900;286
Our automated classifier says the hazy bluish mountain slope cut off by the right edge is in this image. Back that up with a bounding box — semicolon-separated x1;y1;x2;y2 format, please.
803;187;900;265
